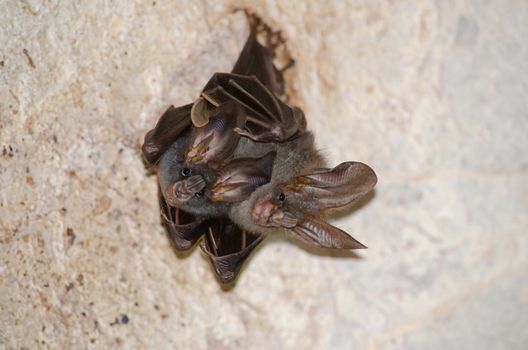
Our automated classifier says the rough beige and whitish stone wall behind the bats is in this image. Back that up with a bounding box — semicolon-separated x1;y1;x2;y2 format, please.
0;0;528;350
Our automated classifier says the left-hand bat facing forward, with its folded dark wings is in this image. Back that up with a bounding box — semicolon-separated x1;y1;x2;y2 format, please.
142;17;292;283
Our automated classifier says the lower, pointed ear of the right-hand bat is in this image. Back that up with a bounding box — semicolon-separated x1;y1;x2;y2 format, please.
292;219;367;249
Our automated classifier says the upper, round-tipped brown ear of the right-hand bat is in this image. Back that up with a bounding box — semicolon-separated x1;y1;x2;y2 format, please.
295;162;378;209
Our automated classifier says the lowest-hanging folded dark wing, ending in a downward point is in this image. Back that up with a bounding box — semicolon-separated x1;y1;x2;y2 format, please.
200;219;264;283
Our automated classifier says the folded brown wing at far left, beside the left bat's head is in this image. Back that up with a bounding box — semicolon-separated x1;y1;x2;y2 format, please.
141;104;192;166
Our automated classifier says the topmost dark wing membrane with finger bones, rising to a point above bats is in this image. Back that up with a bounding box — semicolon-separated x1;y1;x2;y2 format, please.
191;20;306;142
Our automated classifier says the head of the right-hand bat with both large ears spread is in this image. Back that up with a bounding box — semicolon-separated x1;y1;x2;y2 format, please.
230;162;377;249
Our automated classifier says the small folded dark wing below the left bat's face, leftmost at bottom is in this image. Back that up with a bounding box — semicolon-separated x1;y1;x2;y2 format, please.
158;185;210;251
